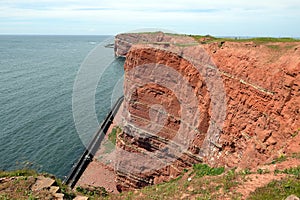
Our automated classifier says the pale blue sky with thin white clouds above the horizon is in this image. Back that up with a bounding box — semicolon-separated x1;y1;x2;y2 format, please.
0;0;300;37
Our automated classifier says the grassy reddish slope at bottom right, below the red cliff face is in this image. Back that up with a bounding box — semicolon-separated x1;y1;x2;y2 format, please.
107;164;300;200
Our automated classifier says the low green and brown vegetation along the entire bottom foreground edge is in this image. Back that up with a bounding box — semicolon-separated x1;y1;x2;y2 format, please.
0;164;300;200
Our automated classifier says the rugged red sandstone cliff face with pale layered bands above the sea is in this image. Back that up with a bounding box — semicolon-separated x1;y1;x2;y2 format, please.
115;33;300;190
